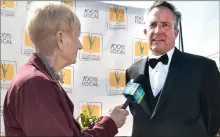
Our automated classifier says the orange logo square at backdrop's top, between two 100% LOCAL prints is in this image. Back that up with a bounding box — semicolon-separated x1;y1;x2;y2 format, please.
109;6;125;23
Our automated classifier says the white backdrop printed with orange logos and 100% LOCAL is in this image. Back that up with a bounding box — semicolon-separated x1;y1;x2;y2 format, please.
1;1;148;136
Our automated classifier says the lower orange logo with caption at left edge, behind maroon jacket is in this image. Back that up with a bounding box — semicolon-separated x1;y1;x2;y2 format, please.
0;60;17;89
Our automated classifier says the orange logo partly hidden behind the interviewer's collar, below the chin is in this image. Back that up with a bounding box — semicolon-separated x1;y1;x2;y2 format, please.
60;66;74;93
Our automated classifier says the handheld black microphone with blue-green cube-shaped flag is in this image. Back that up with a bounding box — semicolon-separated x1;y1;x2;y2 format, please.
122;74;146;109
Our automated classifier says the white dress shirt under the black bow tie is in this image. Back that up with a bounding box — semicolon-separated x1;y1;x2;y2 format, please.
148;47;174;96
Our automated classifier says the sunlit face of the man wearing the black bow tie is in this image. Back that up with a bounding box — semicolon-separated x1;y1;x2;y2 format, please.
145;7;178;54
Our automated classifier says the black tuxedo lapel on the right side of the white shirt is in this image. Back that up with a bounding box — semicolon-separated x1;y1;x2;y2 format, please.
151;48;182;118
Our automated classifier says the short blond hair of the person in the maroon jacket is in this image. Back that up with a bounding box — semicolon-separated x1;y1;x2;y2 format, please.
26;2;80;55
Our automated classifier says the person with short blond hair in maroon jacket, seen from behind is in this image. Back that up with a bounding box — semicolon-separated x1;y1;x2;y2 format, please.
3;3;128;136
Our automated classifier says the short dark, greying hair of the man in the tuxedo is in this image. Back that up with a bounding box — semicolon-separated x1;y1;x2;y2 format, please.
148;0;182;28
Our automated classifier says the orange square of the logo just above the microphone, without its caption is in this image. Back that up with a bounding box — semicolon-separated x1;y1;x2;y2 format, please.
109;70;125;88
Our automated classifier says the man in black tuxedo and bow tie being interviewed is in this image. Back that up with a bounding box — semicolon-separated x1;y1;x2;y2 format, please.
126;1;220;137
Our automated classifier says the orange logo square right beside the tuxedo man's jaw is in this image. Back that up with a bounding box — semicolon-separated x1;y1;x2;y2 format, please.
135;40;149;57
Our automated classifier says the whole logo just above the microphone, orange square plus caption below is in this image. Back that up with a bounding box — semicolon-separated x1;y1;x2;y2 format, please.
107;69;126;95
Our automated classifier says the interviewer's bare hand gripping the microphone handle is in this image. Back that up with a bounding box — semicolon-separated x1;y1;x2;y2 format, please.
107;105;129;128
